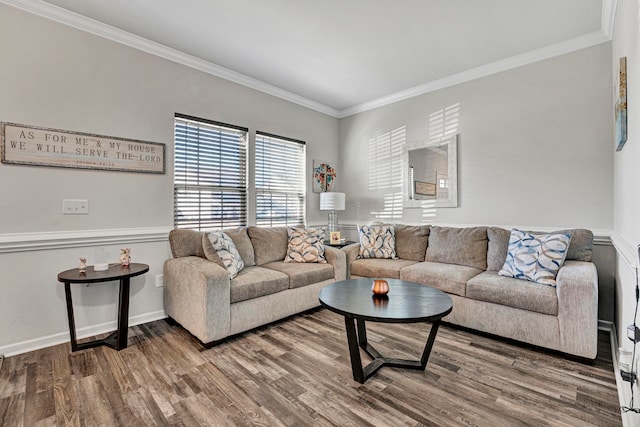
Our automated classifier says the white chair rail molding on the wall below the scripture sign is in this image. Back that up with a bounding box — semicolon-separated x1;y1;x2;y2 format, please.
0;227;173;253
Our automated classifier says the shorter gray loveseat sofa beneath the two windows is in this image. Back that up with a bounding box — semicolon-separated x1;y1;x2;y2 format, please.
163;227;347;344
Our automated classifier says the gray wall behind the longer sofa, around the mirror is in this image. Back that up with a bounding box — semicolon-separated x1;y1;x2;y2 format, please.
340;43;616;321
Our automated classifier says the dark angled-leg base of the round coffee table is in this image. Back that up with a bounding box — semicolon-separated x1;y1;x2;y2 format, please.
344;316;440;384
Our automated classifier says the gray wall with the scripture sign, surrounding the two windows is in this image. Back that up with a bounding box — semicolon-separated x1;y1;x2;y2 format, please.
0;5;339;354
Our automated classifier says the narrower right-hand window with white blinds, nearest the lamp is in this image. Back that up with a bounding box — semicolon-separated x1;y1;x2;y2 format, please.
256;132;306;226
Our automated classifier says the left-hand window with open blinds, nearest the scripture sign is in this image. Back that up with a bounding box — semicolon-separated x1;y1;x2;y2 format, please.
173;114;247;230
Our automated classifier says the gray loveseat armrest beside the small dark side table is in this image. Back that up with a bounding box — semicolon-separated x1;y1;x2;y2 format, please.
163;256;231;343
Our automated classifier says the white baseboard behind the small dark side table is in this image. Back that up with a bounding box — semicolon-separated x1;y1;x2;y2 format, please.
0;310;167;357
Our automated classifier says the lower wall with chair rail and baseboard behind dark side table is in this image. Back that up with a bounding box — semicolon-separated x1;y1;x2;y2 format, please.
0;227;172;357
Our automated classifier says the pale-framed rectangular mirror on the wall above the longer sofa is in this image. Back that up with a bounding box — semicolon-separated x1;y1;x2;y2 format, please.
402;135;458;208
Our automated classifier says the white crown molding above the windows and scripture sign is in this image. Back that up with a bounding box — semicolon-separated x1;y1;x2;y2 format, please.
0;0;339;117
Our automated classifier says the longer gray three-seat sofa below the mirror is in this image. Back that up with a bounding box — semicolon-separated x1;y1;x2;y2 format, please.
343;225;598;359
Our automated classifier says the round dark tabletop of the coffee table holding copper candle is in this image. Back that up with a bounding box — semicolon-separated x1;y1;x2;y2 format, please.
319;279;453;323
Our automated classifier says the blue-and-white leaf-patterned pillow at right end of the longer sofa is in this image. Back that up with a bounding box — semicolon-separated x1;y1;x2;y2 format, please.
498;229;571;286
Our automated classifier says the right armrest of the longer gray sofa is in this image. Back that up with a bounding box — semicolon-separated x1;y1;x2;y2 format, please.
556;261;598;359
